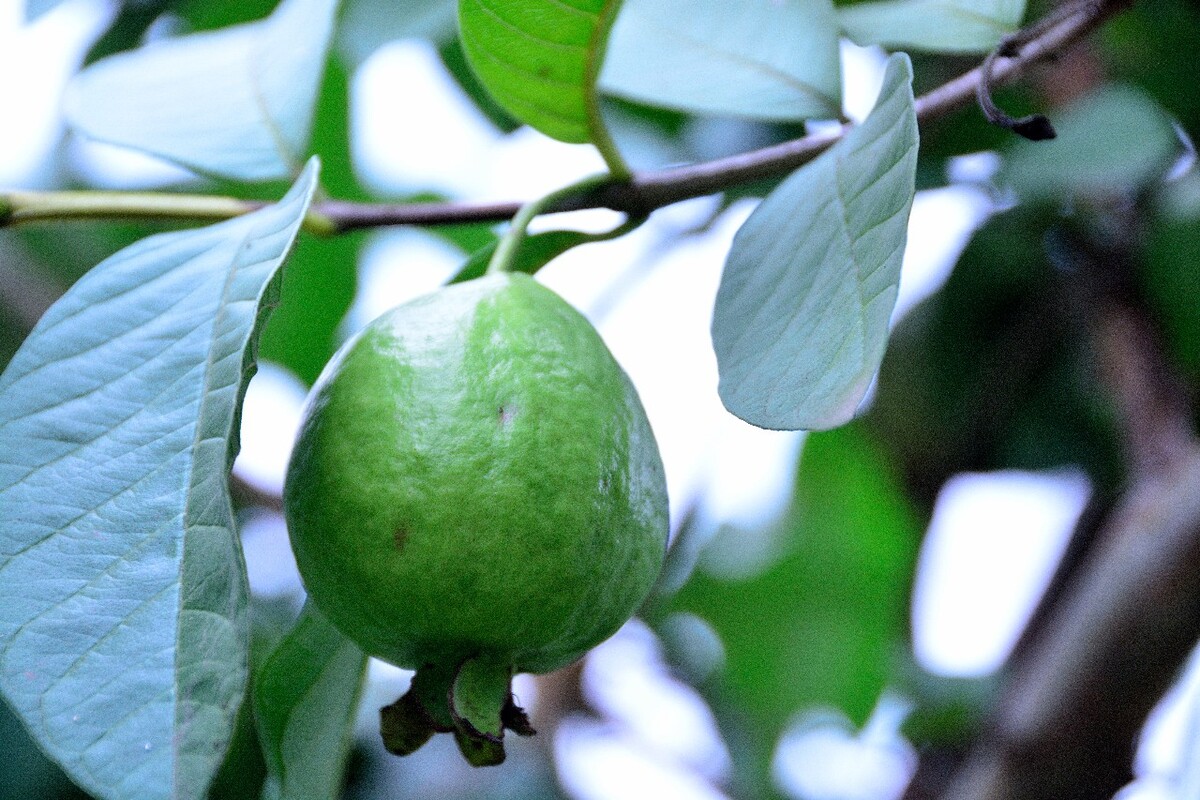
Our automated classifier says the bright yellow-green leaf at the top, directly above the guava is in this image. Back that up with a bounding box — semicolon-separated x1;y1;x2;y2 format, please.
458;0;620;144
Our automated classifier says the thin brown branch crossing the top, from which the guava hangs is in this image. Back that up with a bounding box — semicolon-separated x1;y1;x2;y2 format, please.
0;0;1130;235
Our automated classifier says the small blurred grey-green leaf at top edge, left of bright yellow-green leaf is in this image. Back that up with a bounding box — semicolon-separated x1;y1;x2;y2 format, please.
336;0;457;67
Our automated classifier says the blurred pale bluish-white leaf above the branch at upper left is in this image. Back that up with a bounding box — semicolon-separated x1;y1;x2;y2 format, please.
64;0;337;181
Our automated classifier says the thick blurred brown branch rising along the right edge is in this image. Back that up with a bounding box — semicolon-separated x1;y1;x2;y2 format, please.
940;247;1200;800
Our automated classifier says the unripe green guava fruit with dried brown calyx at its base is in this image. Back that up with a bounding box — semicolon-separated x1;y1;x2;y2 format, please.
284;273;667;765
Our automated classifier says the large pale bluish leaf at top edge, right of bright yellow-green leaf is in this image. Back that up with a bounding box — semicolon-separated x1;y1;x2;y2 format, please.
600;0;841;120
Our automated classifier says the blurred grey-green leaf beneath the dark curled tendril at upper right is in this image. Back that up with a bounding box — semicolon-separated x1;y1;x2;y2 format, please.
997;84;1181;199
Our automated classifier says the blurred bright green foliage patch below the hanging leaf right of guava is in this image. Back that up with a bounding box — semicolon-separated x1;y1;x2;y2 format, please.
670;425;920;782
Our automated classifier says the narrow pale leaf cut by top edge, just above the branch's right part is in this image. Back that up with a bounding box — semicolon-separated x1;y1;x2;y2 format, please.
838;0;1025;53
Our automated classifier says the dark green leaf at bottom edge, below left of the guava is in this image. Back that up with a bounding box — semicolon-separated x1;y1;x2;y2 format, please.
254;603;367;800
